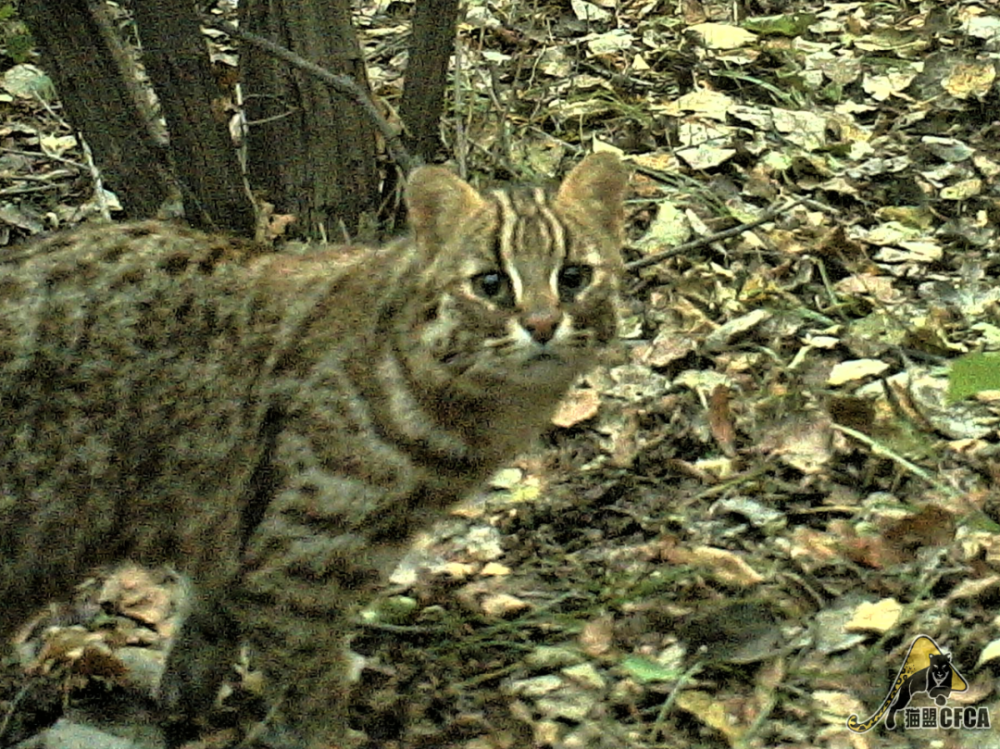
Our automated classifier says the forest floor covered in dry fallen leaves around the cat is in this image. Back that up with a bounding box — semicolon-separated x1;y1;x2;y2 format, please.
0;0;1000;749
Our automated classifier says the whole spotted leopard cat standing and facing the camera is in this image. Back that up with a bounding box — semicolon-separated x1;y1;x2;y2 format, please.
0;153;627;749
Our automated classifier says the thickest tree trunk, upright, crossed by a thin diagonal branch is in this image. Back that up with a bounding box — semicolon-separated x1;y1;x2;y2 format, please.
240;0;378;241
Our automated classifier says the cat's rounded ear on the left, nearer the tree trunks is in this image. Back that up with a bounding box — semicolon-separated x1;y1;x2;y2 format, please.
406;166;485;246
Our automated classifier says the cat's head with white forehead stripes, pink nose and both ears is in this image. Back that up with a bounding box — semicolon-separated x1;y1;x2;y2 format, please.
406;153;627;392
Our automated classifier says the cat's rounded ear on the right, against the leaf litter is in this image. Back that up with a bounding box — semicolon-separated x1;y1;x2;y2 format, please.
556;151;628;236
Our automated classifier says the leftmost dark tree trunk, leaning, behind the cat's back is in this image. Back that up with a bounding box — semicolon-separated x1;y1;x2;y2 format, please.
18;0;170;219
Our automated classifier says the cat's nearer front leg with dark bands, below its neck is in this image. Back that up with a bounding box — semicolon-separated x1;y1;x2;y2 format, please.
219;418;431;749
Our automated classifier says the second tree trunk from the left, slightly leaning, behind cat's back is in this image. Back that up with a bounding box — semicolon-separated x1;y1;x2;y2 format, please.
134;0;256;237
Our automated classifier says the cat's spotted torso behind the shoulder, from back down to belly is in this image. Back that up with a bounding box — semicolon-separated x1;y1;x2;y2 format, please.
0;222;304;608
